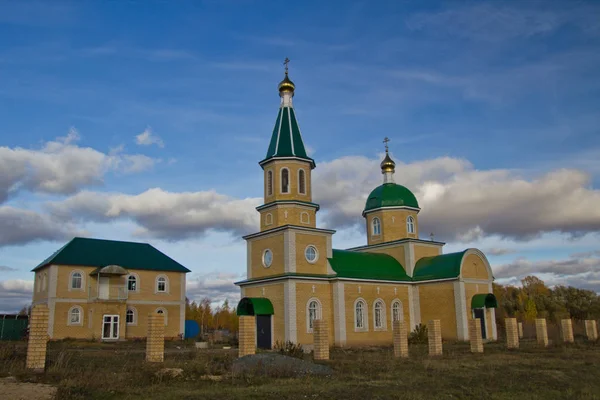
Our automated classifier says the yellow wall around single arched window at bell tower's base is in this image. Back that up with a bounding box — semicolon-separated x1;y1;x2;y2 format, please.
296;282;335;344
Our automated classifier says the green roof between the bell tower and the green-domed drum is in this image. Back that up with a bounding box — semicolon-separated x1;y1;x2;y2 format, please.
329;249;411;281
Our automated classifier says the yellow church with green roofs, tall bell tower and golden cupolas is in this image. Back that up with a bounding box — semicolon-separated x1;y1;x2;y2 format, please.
236;59;497;349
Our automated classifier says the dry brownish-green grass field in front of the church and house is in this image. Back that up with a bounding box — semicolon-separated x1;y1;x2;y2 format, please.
0;341;600;400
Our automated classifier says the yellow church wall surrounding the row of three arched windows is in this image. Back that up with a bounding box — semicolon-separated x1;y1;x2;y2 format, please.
344;283;409;346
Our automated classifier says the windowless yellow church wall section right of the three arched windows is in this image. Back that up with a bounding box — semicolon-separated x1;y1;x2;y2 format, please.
419;282;458;339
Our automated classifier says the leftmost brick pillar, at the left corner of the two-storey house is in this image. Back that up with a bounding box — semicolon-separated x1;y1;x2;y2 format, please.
25;304;49;372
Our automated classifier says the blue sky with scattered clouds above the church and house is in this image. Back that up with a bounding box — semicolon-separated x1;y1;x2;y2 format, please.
0;1;600;311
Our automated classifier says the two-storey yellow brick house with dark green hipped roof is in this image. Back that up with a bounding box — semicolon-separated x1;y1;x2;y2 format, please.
32;237;190;341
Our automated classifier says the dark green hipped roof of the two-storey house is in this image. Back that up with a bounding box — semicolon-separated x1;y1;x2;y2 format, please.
33;237;190;272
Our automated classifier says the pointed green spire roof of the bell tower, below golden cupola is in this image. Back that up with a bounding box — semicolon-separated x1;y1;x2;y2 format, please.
261;106;315;168
